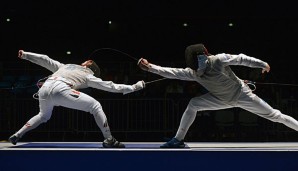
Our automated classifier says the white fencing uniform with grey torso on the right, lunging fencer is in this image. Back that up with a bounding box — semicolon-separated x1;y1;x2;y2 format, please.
148;53;298;140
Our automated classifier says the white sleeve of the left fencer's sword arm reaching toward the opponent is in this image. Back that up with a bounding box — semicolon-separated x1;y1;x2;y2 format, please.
87;75;145;94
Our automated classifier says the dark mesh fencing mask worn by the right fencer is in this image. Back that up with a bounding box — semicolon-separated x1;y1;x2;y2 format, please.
185;44;209;70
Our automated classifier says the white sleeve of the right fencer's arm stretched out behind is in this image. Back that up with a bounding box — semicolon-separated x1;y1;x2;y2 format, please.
217;53;267;68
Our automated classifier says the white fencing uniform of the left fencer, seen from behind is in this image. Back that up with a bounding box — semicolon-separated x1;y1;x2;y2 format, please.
15;52;144;138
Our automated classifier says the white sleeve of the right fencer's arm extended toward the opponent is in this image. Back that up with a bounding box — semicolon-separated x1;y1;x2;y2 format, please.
148;63;195;81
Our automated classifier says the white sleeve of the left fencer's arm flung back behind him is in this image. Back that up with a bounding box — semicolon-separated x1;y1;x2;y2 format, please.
21;52;64;73
